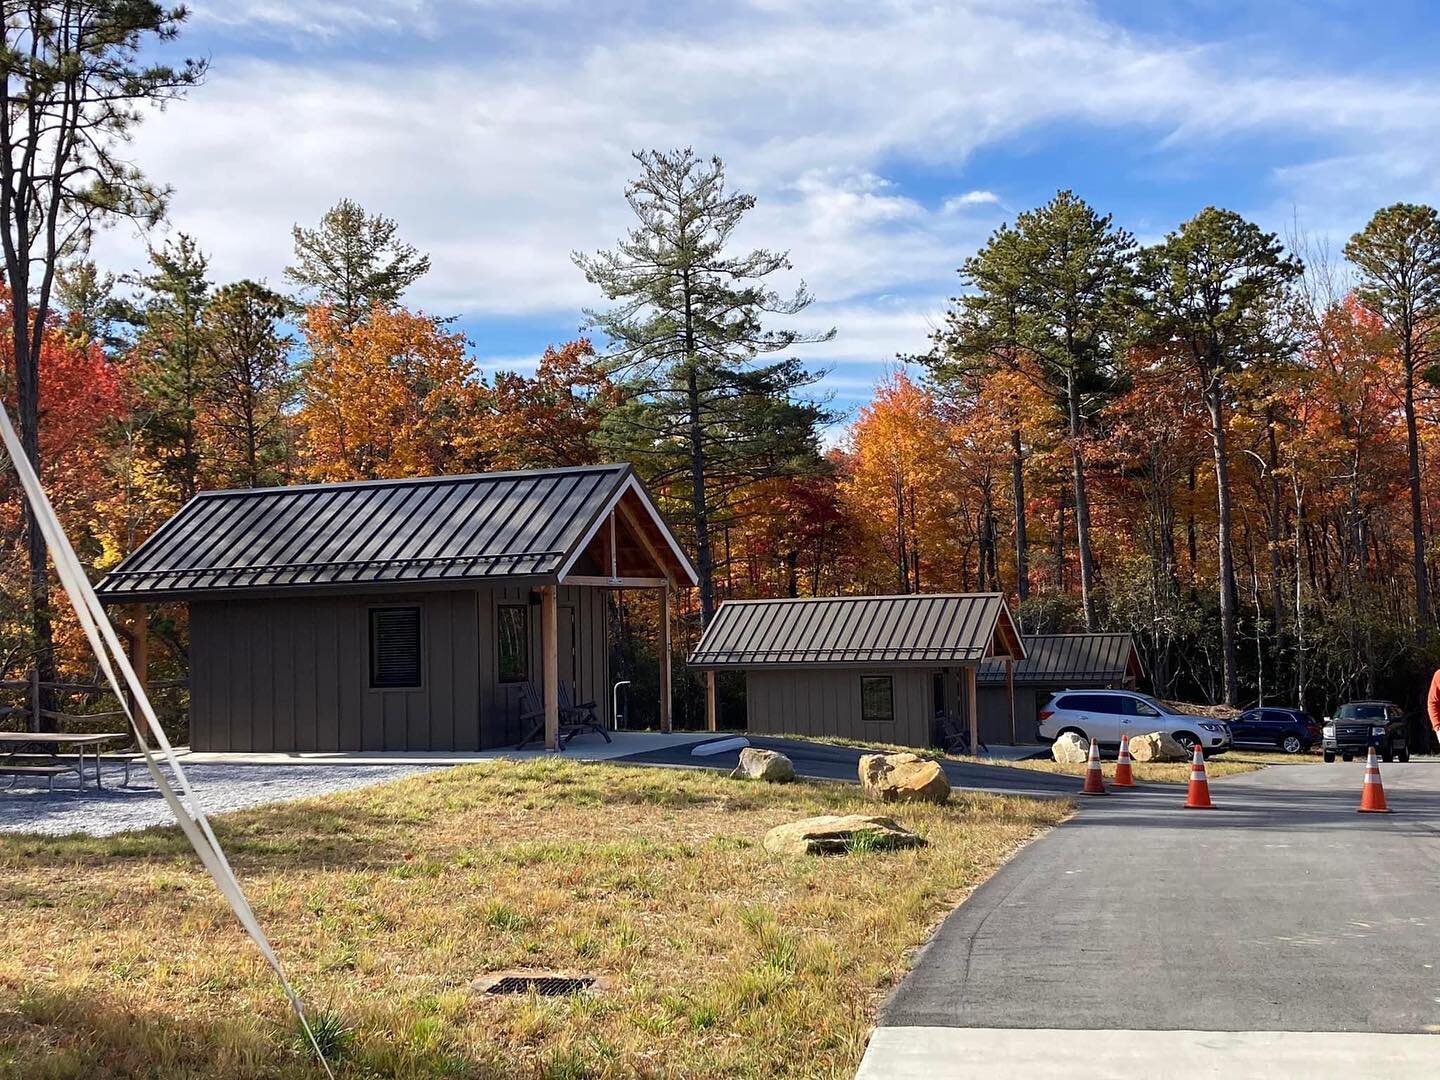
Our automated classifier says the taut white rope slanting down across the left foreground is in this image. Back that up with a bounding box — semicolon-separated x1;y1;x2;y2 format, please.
0;406;334;1080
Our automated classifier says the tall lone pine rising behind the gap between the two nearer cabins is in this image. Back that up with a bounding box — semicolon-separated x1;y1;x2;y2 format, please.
575;148;834;624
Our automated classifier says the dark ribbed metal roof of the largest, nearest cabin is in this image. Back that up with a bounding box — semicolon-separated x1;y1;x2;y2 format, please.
96;465;688;600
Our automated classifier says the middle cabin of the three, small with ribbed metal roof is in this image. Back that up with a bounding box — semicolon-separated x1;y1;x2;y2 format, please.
688;593;1025;747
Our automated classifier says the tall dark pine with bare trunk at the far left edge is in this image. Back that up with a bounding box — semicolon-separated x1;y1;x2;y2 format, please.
0;0;206;723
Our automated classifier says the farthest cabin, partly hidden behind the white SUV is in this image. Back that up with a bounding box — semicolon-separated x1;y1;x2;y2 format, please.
979;634;1145;743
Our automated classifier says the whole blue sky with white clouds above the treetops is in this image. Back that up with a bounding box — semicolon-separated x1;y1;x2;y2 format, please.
96;0;1440;426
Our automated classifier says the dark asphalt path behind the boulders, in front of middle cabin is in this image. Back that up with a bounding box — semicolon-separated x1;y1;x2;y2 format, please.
616;736;1080;798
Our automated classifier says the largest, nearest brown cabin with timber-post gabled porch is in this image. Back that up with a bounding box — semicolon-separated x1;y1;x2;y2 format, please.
96;465;696;752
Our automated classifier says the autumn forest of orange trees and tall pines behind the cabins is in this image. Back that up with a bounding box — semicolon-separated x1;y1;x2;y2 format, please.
0;4;1440;731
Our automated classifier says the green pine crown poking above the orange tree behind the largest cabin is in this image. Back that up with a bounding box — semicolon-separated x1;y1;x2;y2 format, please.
285;199;431;328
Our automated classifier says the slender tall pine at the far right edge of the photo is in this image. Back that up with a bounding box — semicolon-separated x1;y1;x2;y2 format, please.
1345;203;1440;635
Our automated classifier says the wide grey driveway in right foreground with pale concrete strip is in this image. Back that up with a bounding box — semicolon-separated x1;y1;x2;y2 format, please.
861;760;1440;1080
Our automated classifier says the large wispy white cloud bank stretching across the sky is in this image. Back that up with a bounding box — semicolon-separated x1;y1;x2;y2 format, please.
92;0;1440;403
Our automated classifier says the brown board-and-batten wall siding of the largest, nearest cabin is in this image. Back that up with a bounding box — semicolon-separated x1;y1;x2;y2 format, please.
190;586;609;752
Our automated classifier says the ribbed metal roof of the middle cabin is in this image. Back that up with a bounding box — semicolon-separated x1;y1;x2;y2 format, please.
690;593;1022;668
